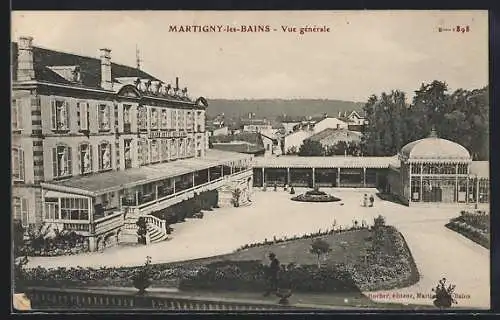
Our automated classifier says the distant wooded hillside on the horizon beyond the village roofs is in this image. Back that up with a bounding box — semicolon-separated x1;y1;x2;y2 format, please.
207;99;364;119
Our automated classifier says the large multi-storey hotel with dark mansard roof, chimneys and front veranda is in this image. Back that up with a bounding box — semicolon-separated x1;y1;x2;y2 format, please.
11;37;253;250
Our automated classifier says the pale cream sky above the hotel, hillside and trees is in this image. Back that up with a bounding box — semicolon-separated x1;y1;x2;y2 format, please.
11;10;488;102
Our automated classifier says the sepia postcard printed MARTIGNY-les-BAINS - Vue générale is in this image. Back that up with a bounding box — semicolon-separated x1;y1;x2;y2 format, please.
10;10;490;312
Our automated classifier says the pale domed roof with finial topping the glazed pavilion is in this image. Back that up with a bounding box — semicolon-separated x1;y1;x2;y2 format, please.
399;129;472;162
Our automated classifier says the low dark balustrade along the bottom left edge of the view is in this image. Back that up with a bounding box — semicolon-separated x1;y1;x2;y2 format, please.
26;287;313;312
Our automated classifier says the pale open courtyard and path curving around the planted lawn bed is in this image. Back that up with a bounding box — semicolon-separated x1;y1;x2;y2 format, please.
23;189;490;308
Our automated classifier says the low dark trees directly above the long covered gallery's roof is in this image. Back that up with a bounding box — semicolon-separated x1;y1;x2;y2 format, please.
287;139;361;156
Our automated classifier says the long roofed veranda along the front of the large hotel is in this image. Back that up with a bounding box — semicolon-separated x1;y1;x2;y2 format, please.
42;150;250;235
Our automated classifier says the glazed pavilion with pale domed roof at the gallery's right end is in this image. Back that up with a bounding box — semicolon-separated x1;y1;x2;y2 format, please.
390;129;472;204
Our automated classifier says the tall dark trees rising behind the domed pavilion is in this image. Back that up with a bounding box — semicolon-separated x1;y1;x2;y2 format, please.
361;80;489;160
